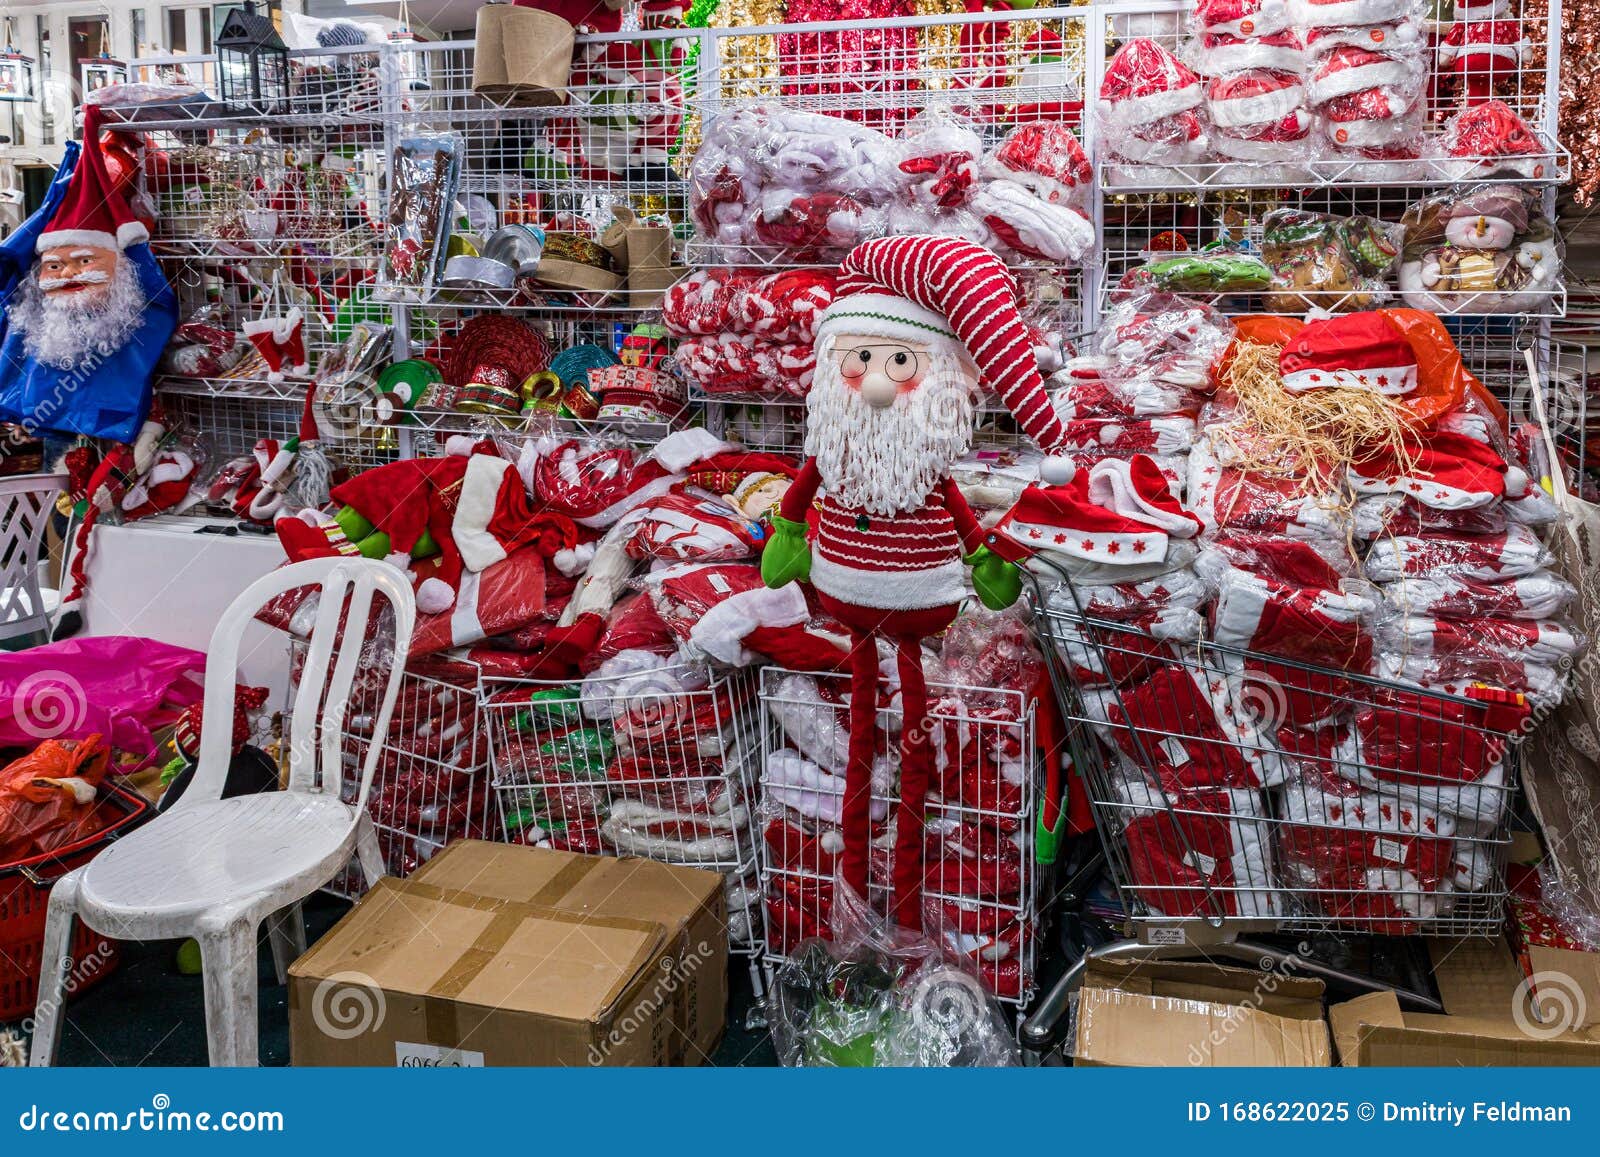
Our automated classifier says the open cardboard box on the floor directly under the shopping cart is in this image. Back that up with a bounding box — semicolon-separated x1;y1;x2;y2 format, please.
1072;960;1333;1067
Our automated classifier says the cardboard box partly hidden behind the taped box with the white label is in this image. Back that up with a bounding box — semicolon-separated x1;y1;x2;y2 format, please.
411;840;728;1064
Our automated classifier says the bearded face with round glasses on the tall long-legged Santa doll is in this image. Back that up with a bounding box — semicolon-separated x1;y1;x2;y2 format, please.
806;333;978;514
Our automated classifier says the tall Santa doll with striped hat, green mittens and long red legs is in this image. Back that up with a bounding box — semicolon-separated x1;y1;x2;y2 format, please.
762;237;1064;928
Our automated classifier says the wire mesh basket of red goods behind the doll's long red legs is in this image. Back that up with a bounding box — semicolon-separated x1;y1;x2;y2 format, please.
760;667;1043;1007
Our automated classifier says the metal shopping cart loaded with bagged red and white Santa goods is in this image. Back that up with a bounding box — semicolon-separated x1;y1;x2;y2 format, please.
990;536;1530;1053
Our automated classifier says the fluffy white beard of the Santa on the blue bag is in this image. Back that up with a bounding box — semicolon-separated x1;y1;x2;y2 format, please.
10;254;146;370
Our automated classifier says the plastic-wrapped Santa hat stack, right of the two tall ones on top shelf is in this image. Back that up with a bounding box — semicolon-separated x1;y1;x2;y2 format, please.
1293;0;1427;179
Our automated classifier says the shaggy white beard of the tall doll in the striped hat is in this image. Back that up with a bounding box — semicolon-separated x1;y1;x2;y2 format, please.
805;334;978;514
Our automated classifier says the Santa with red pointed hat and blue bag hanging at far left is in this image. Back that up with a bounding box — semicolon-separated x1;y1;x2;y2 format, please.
0;104;178;442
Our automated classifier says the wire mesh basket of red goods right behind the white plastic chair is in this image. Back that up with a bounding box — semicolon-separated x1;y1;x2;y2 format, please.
290;640;494;898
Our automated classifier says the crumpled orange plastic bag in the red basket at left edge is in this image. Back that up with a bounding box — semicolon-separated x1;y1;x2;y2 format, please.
0;735;117;864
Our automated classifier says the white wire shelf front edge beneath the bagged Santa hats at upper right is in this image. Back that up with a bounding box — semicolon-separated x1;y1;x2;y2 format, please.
1101;133;1571;194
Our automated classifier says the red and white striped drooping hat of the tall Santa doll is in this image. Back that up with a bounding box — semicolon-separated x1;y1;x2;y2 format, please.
816;237;1066;450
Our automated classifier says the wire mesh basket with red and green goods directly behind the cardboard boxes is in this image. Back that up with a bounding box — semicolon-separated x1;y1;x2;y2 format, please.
480;666;758;959
